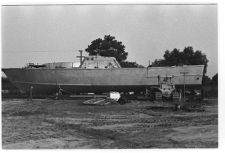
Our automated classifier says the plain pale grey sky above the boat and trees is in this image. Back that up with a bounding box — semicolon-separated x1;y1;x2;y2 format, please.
2;5;218;77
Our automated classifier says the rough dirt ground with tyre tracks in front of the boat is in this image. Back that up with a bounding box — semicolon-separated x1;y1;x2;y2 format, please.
2;99;218;149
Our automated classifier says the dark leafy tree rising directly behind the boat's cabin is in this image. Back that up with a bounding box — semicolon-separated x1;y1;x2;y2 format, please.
85;35;143;67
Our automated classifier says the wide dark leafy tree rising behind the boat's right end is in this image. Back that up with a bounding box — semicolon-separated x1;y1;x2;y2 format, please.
152;46;208;74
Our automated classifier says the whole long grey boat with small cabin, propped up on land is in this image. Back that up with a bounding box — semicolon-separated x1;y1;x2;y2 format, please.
2;55;204;94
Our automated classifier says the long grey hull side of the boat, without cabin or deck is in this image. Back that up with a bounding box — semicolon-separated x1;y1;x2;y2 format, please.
3;66;203;94
